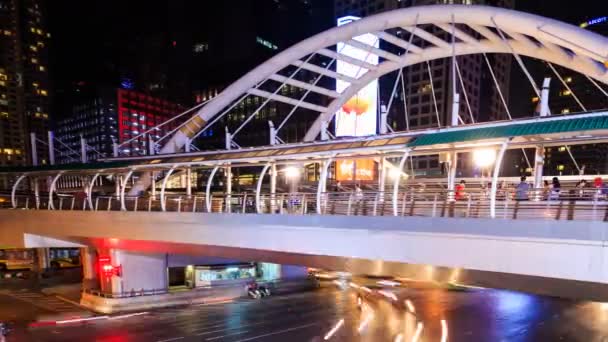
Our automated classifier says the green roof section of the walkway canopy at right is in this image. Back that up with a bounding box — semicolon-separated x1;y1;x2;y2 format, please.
407;116;608;147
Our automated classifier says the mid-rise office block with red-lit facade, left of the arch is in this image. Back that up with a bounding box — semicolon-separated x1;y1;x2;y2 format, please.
55;87;183;163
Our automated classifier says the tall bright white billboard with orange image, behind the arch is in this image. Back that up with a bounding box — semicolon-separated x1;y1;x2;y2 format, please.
336;16;379;137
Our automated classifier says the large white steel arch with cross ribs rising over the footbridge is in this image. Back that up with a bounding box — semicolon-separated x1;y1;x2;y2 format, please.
161;5;608;153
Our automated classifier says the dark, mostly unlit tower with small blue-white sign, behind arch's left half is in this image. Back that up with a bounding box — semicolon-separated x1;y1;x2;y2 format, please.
170;0;333;149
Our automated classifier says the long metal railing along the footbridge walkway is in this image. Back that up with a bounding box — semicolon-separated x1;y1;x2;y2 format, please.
0;188;608;221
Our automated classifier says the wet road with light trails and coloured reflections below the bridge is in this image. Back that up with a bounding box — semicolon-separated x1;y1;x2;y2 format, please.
9;286;608;342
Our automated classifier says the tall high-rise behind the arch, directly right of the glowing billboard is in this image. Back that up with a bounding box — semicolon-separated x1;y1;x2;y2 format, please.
335;0;514;174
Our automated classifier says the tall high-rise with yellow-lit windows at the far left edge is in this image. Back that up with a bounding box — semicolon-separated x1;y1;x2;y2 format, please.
0;0;51;174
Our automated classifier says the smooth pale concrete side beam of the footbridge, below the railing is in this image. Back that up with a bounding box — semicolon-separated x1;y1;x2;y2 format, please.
0;211;608;301
